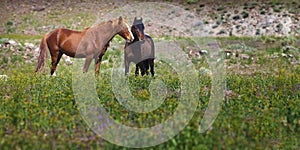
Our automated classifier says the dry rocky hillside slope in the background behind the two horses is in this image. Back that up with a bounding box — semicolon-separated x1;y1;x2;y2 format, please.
0;0;300;36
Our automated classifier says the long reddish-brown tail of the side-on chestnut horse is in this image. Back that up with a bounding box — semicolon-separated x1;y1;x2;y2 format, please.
35;33;48;72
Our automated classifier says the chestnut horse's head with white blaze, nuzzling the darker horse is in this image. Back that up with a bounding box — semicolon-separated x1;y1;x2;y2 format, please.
118;17;134;41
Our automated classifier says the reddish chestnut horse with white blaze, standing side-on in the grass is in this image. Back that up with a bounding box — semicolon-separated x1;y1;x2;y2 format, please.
35;17;134;75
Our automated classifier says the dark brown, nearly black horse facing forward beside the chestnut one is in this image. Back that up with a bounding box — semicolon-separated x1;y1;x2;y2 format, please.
124;17;155;76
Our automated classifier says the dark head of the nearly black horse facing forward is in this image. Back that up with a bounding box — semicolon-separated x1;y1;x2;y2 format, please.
131;17;145;40
